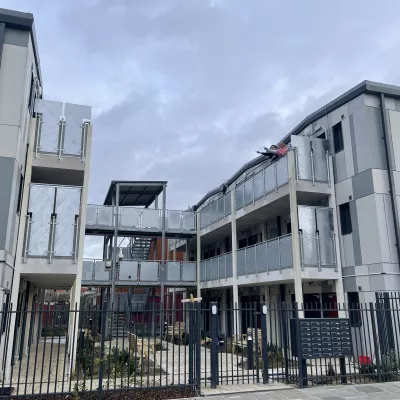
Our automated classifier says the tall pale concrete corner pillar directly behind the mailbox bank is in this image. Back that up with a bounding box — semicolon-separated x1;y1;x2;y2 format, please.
288;150;304;318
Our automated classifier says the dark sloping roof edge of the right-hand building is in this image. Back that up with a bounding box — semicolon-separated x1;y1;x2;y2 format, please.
194;81;400;210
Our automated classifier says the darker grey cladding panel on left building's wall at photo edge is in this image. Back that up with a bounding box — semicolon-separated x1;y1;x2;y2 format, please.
0;157;15;250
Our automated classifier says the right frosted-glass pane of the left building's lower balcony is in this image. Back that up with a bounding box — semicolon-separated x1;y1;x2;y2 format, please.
54;187;81;257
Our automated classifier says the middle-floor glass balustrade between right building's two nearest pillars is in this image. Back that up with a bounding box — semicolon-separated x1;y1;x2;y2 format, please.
237;235;293;276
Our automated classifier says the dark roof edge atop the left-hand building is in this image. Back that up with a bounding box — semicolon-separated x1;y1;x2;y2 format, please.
0;8;43;88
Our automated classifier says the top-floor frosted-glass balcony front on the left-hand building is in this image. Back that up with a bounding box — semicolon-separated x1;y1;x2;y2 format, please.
34;99;91;161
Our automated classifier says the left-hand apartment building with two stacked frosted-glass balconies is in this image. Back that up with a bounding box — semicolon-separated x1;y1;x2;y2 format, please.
0;9;92;369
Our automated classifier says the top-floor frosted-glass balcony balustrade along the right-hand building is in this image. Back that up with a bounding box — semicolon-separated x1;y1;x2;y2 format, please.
199;136;330;229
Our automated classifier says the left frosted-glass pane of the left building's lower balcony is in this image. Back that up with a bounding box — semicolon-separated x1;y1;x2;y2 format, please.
28;184;56;256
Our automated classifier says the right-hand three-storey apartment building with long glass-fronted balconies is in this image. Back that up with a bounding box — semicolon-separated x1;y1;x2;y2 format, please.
170;81;400;330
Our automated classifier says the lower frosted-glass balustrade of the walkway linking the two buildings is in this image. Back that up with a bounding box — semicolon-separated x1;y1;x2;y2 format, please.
82;260;196;287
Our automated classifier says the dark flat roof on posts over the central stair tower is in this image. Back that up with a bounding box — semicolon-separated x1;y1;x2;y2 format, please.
104;181;167;207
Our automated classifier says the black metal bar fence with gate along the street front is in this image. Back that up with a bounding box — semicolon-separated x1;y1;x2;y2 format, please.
0;293;400;398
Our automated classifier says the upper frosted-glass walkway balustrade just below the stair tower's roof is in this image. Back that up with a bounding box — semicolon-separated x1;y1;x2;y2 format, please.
86;204;196;236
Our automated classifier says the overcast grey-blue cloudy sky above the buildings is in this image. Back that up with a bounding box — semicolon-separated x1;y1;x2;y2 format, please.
4;0;400;256
